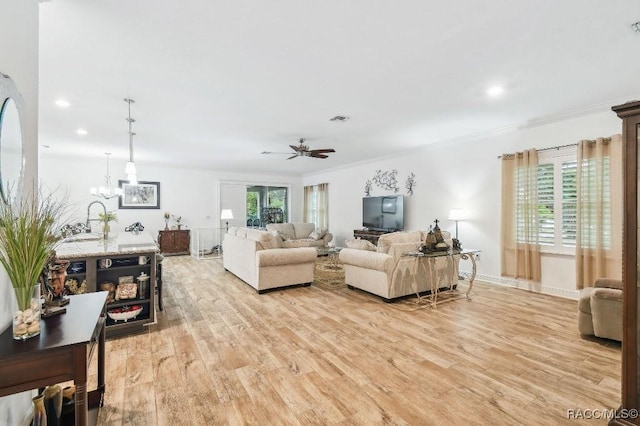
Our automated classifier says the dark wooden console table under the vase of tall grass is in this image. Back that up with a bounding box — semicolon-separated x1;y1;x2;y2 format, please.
0;291;108;426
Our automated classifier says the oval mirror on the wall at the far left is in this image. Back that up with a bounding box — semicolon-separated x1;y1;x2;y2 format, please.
0;74;24;202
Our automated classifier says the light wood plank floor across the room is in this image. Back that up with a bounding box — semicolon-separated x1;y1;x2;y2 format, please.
90;256;621;426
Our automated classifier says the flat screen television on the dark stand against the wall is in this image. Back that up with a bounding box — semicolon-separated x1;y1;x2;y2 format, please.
362;195;404;231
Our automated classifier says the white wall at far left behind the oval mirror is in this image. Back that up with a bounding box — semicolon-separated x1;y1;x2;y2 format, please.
0;0;38;425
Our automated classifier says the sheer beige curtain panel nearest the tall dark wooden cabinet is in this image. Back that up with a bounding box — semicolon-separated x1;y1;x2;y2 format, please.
576;135;623;289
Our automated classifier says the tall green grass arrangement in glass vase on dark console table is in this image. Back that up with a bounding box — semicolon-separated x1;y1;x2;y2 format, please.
0;190;66;340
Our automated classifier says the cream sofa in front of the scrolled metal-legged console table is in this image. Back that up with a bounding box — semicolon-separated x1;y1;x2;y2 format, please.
340;231;460;302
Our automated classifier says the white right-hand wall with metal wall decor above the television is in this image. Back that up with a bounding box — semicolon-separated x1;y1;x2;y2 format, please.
303;111;622;298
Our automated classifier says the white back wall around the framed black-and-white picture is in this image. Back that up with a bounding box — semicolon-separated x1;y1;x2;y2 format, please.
39;156;302;241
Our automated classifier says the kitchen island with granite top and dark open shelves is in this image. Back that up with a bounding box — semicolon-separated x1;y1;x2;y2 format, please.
56;232;159;337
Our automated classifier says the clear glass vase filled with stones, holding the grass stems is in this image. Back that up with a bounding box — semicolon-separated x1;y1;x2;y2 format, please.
13;284;41;340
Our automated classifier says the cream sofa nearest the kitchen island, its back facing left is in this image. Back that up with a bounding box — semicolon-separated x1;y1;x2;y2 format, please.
222;227;317;293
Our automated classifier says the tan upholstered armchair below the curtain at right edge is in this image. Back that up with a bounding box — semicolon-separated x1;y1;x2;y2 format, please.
578;278;622;341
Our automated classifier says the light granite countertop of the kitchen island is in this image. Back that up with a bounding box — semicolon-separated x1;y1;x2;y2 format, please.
56;232;160;259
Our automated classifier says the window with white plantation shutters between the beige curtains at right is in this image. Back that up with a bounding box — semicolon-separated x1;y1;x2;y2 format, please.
516;147;611;253
